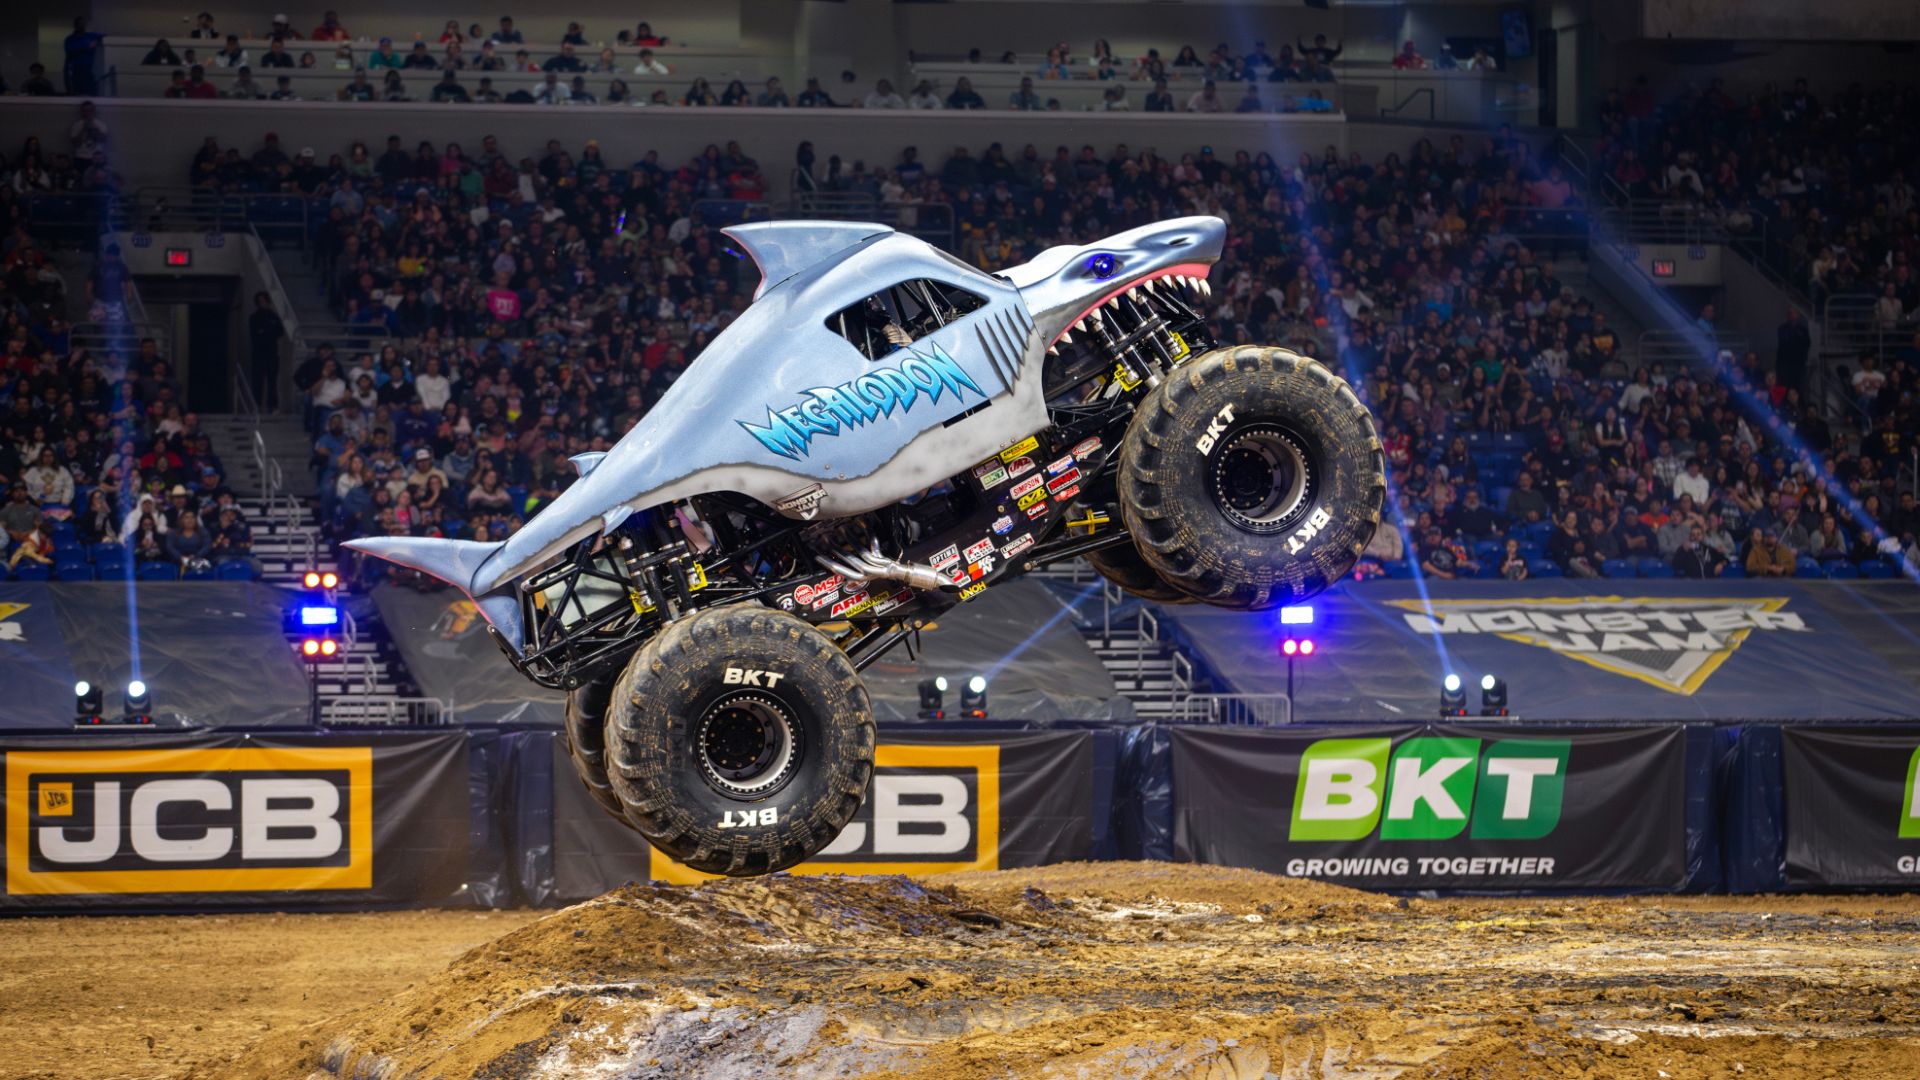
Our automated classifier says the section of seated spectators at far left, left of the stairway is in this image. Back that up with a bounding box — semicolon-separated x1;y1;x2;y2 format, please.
0;146;253;580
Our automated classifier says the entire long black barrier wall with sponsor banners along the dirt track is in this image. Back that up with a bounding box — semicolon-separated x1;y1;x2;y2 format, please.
0;723;1920;913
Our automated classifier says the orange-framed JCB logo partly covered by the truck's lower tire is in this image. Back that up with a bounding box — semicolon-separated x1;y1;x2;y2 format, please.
651;744;1000;884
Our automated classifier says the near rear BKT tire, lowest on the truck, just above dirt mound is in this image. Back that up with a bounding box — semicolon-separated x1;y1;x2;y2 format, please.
607;607;874;876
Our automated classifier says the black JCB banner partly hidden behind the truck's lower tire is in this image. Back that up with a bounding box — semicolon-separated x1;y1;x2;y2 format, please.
549;728;1092;901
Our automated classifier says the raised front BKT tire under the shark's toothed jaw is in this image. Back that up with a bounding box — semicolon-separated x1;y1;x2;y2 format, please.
1119;346;1386;609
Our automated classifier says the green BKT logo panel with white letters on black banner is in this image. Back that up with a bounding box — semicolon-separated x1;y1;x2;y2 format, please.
1286;738;1571;840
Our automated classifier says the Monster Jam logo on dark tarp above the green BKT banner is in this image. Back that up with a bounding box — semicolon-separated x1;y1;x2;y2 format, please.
1388;596;1807;694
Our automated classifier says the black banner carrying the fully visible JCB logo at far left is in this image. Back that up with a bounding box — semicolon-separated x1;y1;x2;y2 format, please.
0;732;468;909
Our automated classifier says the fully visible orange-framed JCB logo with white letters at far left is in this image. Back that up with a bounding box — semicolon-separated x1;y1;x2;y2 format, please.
6;748;372;896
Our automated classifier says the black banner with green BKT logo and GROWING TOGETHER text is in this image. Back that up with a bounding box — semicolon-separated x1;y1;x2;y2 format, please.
1173;724;1686;890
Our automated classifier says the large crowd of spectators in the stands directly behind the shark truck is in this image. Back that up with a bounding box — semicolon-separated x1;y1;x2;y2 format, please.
153;121;1920;577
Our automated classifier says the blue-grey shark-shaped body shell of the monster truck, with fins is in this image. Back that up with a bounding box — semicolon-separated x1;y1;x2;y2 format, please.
348;217;1225;648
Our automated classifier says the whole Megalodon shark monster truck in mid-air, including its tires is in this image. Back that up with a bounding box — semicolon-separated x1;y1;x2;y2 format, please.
348;217;1384;874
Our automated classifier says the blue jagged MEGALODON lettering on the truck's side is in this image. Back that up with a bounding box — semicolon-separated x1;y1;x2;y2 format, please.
735;346;987;461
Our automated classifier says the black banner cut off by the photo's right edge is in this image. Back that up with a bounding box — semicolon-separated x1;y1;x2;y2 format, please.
1780;726;1920;890
